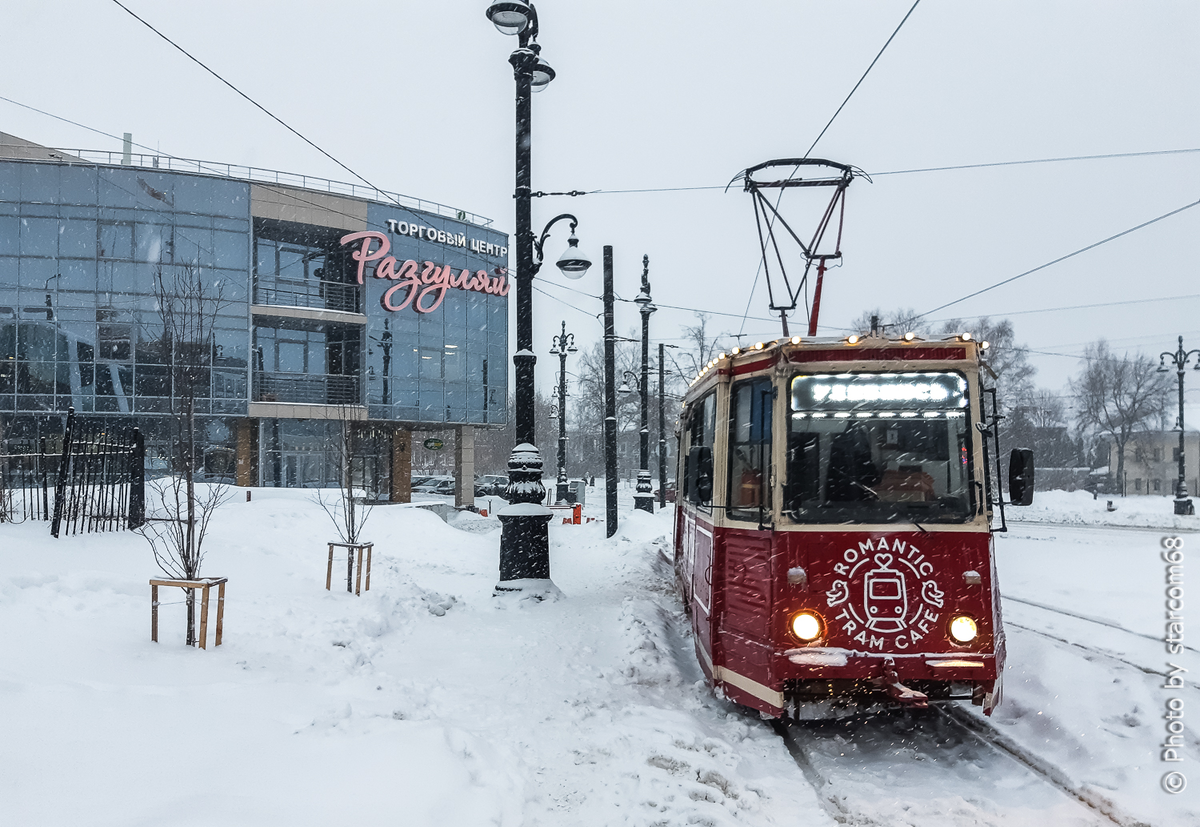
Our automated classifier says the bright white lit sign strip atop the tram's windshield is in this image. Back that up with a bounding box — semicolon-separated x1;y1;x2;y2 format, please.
792;373;967;412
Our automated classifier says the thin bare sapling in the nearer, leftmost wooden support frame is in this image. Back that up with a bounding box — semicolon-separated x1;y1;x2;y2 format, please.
138;264;229;646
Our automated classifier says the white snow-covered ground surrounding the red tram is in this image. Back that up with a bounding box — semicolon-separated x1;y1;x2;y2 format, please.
0;485;1200;827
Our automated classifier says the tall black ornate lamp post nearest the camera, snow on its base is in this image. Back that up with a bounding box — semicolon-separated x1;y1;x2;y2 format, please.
487;0;592;592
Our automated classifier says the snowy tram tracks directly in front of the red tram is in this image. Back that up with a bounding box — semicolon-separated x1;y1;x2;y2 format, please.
773;705;1150;827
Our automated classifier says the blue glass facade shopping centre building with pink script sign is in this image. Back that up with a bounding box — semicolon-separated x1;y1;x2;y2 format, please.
0;136;508;492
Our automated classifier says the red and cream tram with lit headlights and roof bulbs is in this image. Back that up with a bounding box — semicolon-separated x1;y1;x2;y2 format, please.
674;334;1032;718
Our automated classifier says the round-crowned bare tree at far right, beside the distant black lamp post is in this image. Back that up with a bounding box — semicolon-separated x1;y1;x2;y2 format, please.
1070;338;1171;494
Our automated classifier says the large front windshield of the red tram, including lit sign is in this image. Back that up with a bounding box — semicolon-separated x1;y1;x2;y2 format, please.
784;372;971;523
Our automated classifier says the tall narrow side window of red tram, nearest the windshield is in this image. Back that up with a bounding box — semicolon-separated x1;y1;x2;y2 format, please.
727;379;773;520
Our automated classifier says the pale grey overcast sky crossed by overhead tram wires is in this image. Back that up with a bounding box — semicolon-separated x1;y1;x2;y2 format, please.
0;0;1200;410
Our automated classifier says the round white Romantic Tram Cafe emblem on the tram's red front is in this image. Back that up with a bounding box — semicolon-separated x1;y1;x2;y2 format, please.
826;538;946;649
